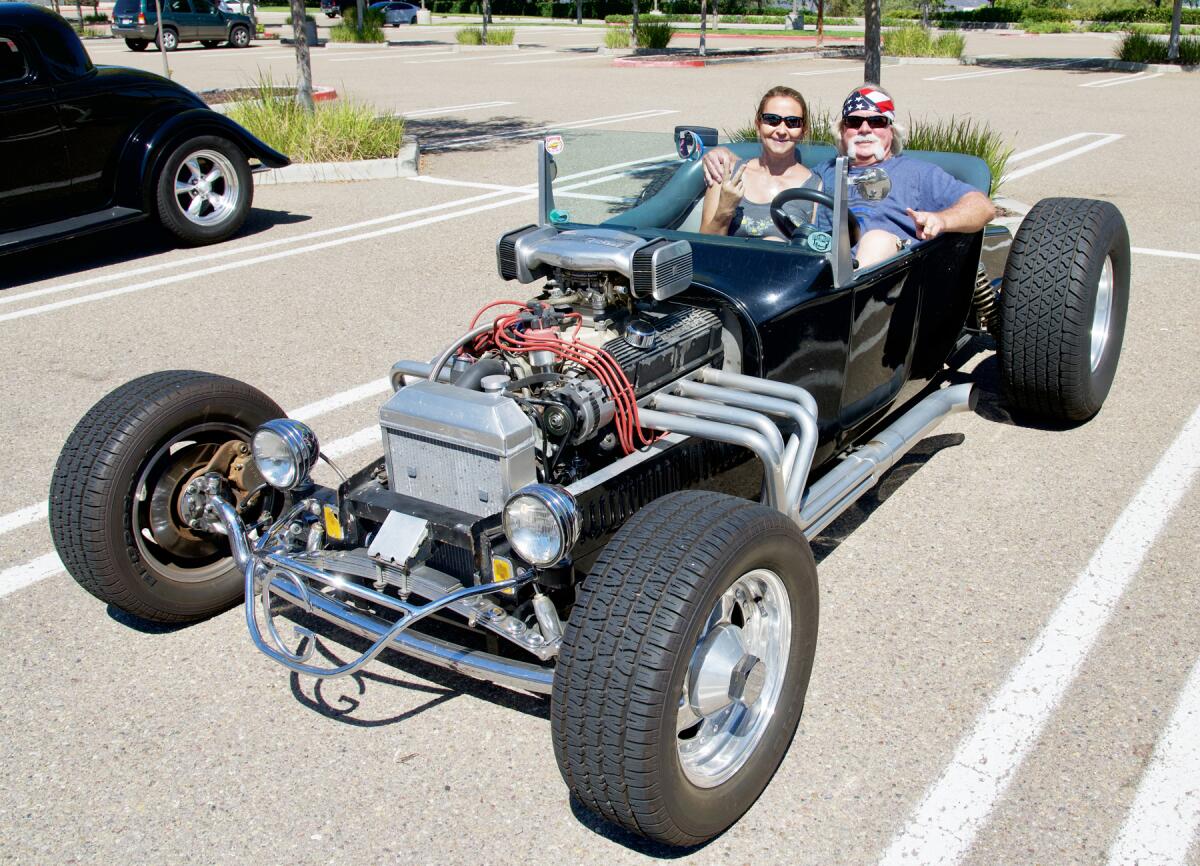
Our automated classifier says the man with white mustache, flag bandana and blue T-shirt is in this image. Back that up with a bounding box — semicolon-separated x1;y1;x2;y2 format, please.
704;84;996;267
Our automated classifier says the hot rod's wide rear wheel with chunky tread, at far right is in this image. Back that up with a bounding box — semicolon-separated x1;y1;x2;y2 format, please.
1000;198;1129;422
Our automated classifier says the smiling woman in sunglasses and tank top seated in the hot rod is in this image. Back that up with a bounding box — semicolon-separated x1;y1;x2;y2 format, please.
700;86;821;241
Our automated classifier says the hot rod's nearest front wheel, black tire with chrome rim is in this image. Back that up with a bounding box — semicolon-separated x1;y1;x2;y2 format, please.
551;491;818;846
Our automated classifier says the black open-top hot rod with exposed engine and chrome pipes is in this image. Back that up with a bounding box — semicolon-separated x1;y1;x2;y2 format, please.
50;131;1129;846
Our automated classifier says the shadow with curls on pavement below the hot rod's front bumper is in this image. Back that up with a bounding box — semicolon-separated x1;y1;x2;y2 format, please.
274;608;550;728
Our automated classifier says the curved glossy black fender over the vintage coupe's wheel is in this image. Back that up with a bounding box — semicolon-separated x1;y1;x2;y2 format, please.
116;108;292;214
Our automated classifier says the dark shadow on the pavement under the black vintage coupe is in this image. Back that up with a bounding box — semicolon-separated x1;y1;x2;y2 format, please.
0;208;312;290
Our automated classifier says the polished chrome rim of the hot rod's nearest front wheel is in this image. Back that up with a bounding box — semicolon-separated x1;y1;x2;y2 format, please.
676;569;792;788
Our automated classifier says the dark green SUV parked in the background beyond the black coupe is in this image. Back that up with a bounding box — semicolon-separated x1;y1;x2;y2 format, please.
113;0;254;52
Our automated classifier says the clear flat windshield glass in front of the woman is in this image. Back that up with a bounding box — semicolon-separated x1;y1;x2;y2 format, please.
544;130;703;228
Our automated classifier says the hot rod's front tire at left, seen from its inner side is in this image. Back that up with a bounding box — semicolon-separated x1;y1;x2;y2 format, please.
49;371;284;623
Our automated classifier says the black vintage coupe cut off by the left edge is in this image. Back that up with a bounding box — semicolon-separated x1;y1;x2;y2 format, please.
0;4;288;254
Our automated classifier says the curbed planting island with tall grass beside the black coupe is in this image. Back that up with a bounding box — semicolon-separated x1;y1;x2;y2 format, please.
200;82;420;185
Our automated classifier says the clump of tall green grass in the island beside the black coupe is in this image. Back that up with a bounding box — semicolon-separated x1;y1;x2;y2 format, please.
229;77;404;162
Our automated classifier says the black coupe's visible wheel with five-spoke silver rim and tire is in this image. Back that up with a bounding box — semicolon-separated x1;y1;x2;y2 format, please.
155;136;254;246
